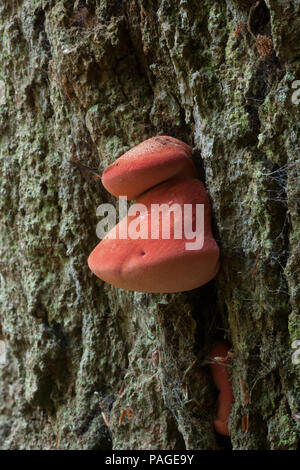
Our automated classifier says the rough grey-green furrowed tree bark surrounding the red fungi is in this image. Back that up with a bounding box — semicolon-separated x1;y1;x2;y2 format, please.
0;0;300;450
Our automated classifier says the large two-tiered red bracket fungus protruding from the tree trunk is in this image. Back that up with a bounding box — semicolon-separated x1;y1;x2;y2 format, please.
88;136;219;293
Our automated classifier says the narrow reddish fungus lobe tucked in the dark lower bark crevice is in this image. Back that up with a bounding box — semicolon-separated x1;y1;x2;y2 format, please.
209;341;233;436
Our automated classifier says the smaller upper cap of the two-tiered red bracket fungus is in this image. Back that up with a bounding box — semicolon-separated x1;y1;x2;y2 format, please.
102;136;196;200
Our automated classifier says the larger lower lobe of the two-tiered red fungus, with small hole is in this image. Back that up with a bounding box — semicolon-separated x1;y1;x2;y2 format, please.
88;178;219;293
